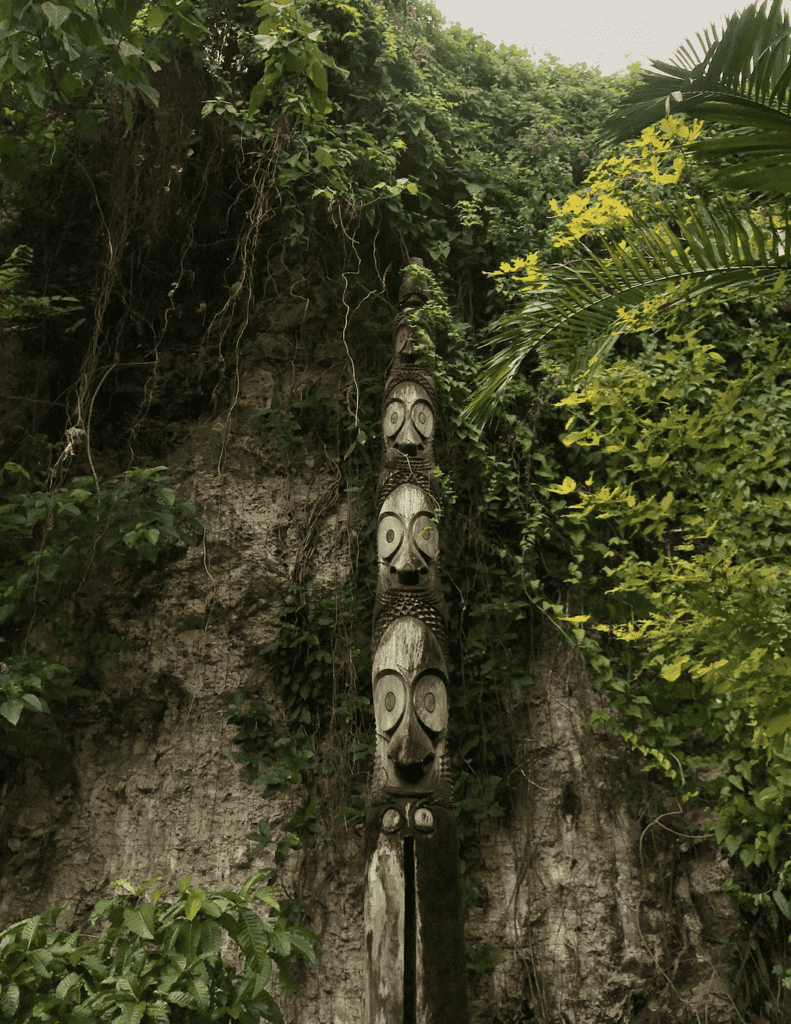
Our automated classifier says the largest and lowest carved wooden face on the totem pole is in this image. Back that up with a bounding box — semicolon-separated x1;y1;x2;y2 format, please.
374;617;448;793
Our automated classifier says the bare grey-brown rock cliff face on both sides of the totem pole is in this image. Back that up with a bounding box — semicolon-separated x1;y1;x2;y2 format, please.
0;282;735;1024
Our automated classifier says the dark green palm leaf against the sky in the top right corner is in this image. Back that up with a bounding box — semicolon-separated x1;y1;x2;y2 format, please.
601;0;791;193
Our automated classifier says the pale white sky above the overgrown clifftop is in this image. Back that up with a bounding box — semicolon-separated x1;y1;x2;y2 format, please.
434;0;788;75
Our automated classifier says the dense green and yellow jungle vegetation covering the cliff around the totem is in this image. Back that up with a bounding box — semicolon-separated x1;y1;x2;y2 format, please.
0;0;791;1021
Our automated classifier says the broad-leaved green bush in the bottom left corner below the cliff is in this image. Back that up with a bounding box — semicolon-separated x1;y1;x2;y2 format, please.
0;870;316;1024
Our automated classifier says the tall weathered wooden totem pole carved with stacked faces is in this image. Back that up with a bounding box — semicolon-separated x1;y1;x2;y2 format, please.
363;259;467;1024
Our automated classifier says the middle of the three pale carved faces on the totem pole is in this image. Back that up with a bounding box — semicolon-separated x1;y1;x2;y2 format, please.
376;483;440;589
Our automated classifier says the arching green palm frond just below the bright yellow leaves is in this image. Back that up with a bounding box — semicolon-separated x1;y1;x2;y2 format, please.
466;200;791;423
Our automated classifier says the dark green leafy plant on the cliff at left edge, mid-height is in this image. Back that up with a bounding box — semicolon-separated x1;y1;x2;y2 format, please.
0;463;211;760
